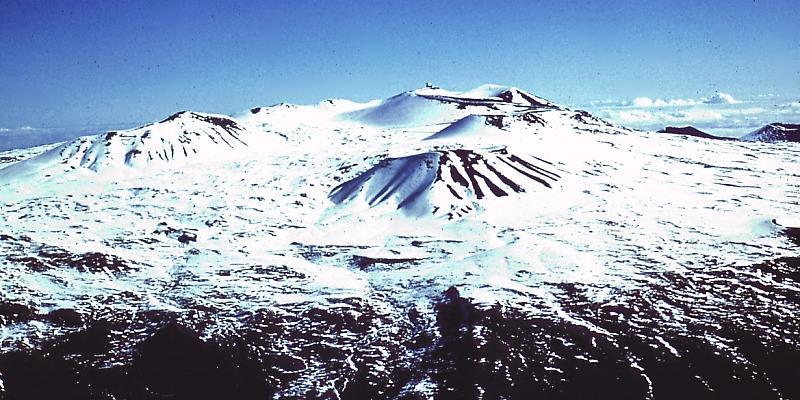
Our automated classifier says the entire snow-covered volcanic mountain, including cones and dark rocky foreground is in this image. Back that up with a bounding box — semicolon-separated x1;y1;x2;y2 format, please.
0;85;800;398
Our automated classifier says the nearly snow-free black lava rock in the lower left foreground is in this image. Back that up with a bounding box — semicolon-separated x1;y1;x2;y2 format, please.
0;321;278;400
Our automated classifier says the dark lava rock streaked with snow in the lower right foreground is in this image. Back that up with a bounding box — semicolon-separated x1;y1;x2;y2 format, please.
412;282;800;399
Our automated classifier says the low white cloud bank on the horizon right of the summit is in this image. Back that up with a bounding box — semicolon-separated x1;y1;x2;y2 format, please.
582;92;800;137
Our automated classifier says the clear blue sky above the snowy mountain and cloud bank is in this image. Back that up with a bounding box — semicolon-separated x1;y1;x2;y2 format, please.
0;0;800;133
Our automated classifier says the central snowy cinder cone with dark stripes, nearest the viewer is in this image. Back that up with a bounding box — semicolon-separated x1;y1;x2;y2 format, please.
329;149;560;219
